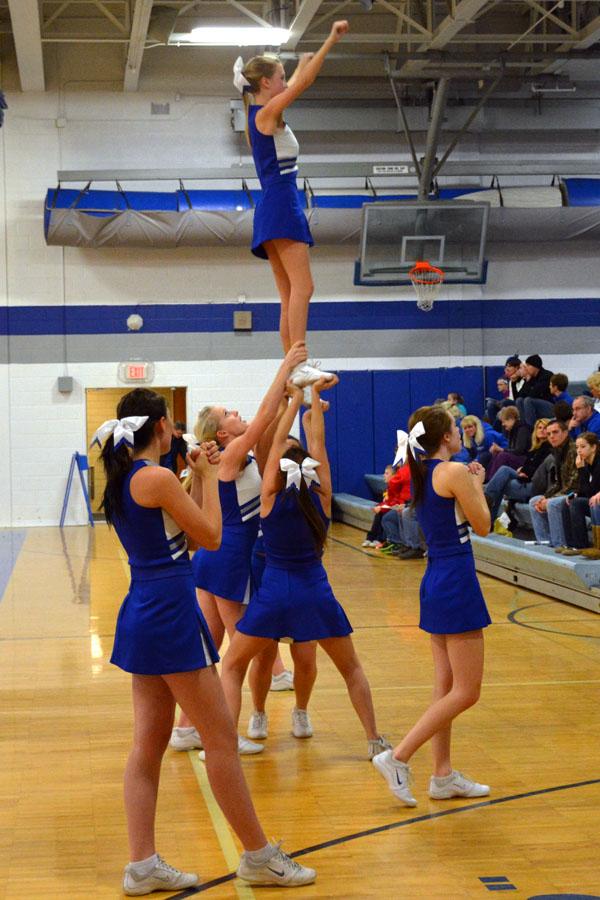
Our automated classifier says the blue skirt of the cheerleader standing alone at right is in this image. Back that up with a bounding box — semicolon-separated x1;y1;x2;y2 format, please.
419;552;492;634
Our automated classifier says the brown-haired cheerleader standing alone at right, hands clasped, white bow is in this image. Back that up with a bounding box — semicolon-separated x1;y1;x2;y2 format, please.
373;406;491;806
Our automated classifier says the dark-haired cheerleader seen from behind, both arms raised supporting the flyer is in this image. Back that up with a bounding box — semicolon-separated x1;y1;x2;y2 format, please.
222;377;391;758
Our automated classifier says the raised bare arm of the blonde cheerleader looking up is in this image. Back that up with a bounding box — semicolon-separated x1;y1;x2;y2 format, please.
219;341;307;481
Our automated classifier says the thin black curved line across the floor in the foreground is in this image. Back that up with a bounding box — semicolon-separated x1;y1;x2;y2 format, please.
171;778;600;900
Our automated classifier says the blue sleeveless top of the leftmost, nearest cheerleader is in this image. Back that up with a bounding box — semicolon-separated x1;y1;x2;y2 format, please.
114;459;191;581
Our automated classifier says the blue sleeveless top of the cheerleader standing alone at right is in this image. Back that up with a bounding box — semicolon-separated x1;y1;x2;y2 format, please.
416;459;473;559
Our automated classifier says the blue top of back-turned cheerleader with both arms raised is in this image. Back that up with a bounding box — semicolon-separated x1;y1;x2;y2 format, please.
260;487;329;569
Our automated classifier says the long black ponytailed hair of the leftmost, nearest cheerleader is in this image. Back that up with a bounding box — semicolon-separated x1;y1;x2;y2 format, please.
100;388;168;525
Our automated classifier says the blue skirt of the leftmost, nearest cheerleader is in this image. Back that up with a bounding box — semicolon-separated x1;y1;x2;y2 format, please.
110;570;219;675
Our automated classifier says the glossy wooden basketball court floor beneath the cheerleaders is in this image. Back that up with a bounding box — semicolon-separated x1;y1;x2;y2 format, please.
0;525;600;900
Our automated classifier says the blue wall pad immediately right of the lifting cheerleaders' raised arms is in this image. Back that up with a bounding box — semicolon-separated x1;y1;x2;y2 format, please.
332;372;375;498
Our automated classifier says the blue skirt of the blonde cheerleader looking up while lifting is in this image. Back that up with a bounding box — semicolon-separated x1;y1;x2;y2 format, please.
192;516;258;603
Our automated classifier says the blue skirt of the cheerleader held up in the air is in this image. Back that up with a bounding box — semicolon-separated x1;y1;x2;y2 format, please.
251;179;314;259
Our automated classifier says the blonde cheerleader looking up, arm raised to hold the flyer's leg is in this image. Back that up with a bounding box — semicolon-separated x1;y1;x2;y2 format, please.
171;342;306;755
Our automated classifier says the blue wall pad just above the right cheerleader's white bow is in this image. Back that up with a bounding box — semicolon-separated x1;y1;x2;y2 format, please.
373;369;412;473
